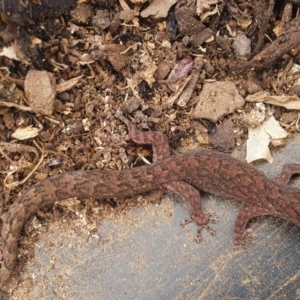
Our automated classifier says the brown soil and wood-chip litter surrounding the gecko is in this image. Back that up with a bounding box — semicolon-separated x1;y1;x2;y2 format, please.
0;0;300;298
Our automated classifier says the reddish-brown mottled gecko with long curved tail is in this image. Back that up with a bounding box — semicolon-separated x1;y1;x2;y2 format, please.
0;113;300;290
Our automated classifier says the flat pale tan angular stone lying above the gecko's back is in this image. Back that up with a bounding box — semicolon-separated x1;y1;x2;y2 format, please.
192;81;245;122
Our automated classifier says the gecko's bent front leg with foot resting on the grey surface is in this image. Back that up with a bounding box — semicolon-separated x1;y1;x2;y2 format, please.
234;207;274;250
